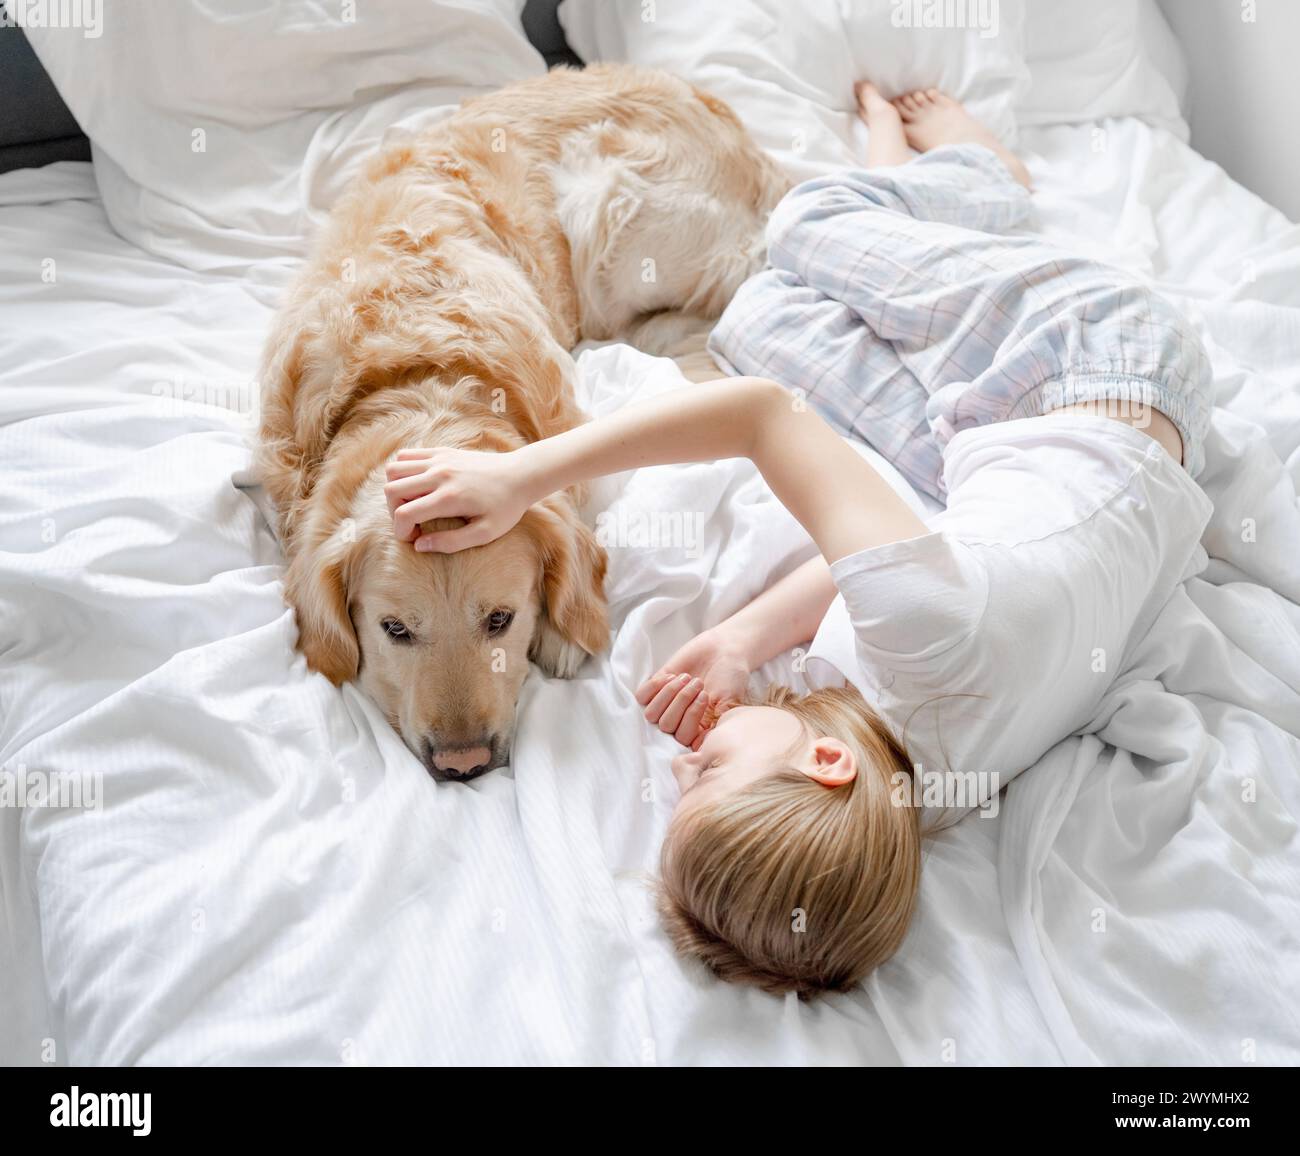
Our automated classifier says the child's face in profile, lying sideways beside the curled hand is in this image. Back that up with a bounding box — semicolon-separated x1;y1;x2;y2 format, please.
672;706;811;815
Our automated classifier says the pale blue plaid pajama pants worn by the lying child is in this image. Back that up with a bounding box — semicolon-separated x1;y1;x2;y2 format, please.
709;144;1213;501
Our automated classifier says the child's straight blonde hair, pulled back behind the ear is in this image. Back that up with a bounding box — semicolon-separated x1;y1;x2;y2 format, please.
658;687;922;999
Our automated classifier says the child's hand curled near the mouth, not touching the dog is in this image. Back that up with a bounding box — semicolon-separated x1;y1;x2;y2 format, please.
637;629;750;750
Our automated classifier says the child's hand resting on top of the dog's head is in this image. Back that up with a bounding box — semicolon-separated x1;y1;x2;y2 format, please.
384;447;533;554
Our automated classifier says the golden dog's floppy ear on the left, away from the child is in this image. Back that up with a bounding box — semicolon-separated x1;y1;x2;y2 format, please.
285;518;361;687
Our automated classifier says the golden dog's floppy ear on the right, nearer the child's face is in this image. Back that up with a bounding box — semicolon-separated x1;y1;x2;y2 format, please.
521;494;610;679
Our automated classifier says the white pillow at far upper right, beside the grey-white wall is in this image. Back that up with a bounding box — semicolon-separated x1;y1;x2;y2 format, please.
1017;0;1187;140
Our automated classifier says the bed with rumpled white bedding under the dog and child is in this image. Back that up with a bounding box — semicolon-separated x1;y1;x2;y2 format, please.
0;0;1300;1065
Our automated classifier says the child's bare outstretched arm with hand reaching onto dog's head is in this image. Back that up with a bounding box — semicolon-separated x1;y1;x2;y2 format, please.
385;377;926;562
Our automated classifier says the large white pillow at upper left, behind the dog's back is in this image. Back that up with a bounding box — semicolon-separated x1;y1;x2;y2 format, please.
27;0;546;282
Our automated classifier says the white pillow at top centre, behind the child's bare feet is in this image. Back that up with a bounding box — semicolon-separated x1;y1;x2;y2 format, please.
559;0;1028;179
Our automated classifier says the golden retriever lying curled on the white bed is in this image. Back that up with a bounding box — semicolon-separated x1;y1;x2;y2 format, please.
250;65;789;780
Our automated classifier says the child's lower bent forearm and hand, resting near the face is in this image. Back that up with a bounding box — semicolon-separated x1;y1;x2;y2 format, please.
637;555;835;746
